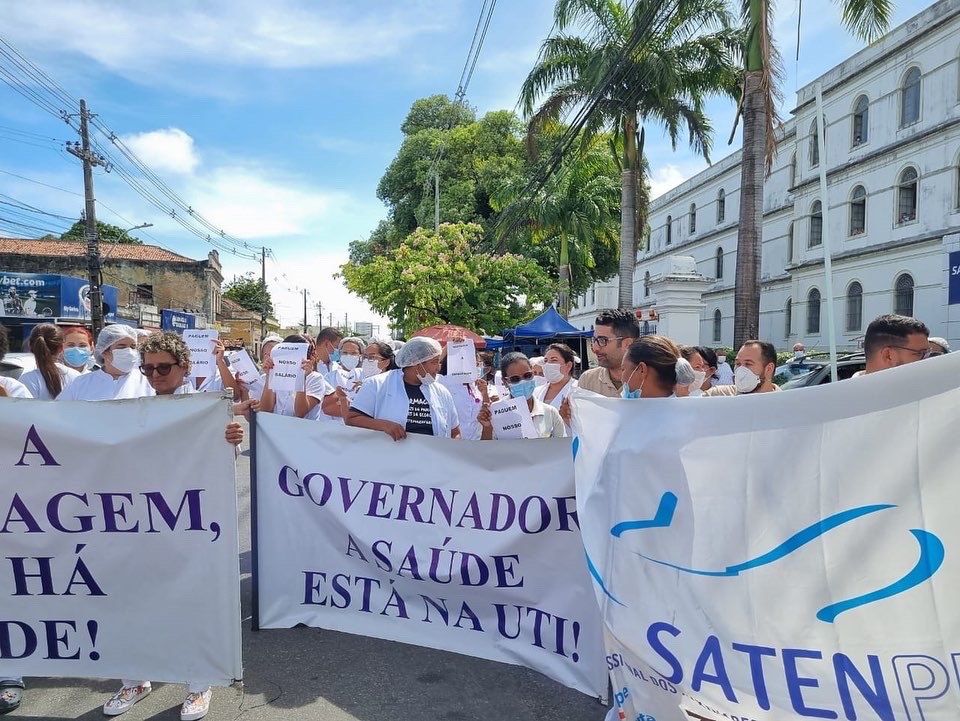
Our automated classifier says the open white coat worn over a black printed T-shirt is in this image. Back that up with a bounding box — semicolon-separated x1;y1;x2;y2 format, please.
350;368;460;438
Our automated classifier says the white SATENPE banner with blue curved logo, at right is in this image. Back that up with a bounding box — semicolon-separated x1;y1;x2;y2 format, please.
574;355;960;721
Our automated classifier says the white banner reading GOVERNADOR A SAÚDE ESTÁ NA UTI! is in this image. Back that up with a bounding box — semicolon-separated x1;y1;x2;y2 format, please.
256;413;607;696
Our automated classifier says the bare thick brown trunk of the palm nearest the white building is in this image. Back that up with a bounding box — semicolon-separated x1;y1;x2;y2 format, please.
733;70;767;350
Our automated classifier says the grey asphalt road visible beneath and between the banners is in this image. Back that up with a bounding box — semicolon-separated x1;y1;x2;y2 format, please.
13;422;606;721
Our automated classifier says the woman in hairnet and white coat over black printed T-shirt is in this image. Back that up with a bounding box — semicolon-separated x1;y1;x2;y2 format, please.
346;336;460;441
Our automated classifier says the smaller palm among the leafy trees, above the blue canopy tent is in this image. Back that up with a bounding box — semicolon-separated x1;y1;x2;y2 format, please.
491;138;620;318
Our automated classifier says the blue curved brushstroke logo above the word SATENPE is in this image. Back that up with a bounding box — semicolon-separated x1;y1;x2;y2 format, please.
587;492;946;623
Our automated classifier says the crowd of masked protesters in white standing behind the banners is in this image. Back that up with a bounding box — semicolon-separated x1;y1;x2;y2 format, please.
0;310;950;721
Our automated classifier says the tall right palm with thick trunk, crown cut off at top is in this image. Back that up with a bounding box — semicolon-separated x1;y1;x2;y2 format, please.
733;0;893;348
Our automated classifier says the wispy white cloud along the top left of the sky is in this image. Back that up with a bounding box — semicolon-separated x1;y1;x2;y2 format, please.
4;0;456;79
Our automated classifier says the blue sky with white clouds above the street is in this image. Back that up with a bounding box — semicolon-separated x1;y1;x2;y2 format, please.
0;0;928;324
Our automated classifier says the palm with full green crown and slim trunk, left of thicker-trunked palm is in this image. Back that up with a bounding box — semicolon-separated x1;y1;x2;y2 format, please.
520;0;741;308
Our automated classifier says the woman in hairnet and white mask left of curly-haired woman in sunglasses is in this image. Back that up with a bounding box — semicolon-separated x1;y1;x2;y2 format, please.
57;323;155;401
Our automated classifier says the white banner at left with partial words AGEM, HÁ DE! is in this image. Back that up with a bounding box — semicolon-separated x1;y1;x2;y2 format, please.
0;394;242;686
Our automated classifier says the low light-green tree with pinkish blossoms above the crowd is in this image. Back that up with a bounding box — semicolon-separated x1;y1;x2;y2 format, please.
340;223;555;335
